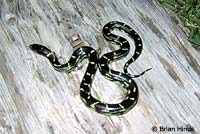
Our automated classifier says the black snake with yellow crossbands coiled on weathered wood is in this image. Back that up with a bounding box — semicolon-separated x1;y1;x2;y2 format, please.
29;21;150;115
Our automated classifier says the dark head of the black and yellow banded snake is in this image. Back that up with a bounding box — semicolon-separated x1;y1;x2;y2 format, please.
29;44;51;57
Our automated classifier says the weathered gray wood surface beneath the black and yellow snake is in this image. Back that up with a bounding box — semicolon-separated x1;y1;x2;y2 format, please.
0;0;200;134
